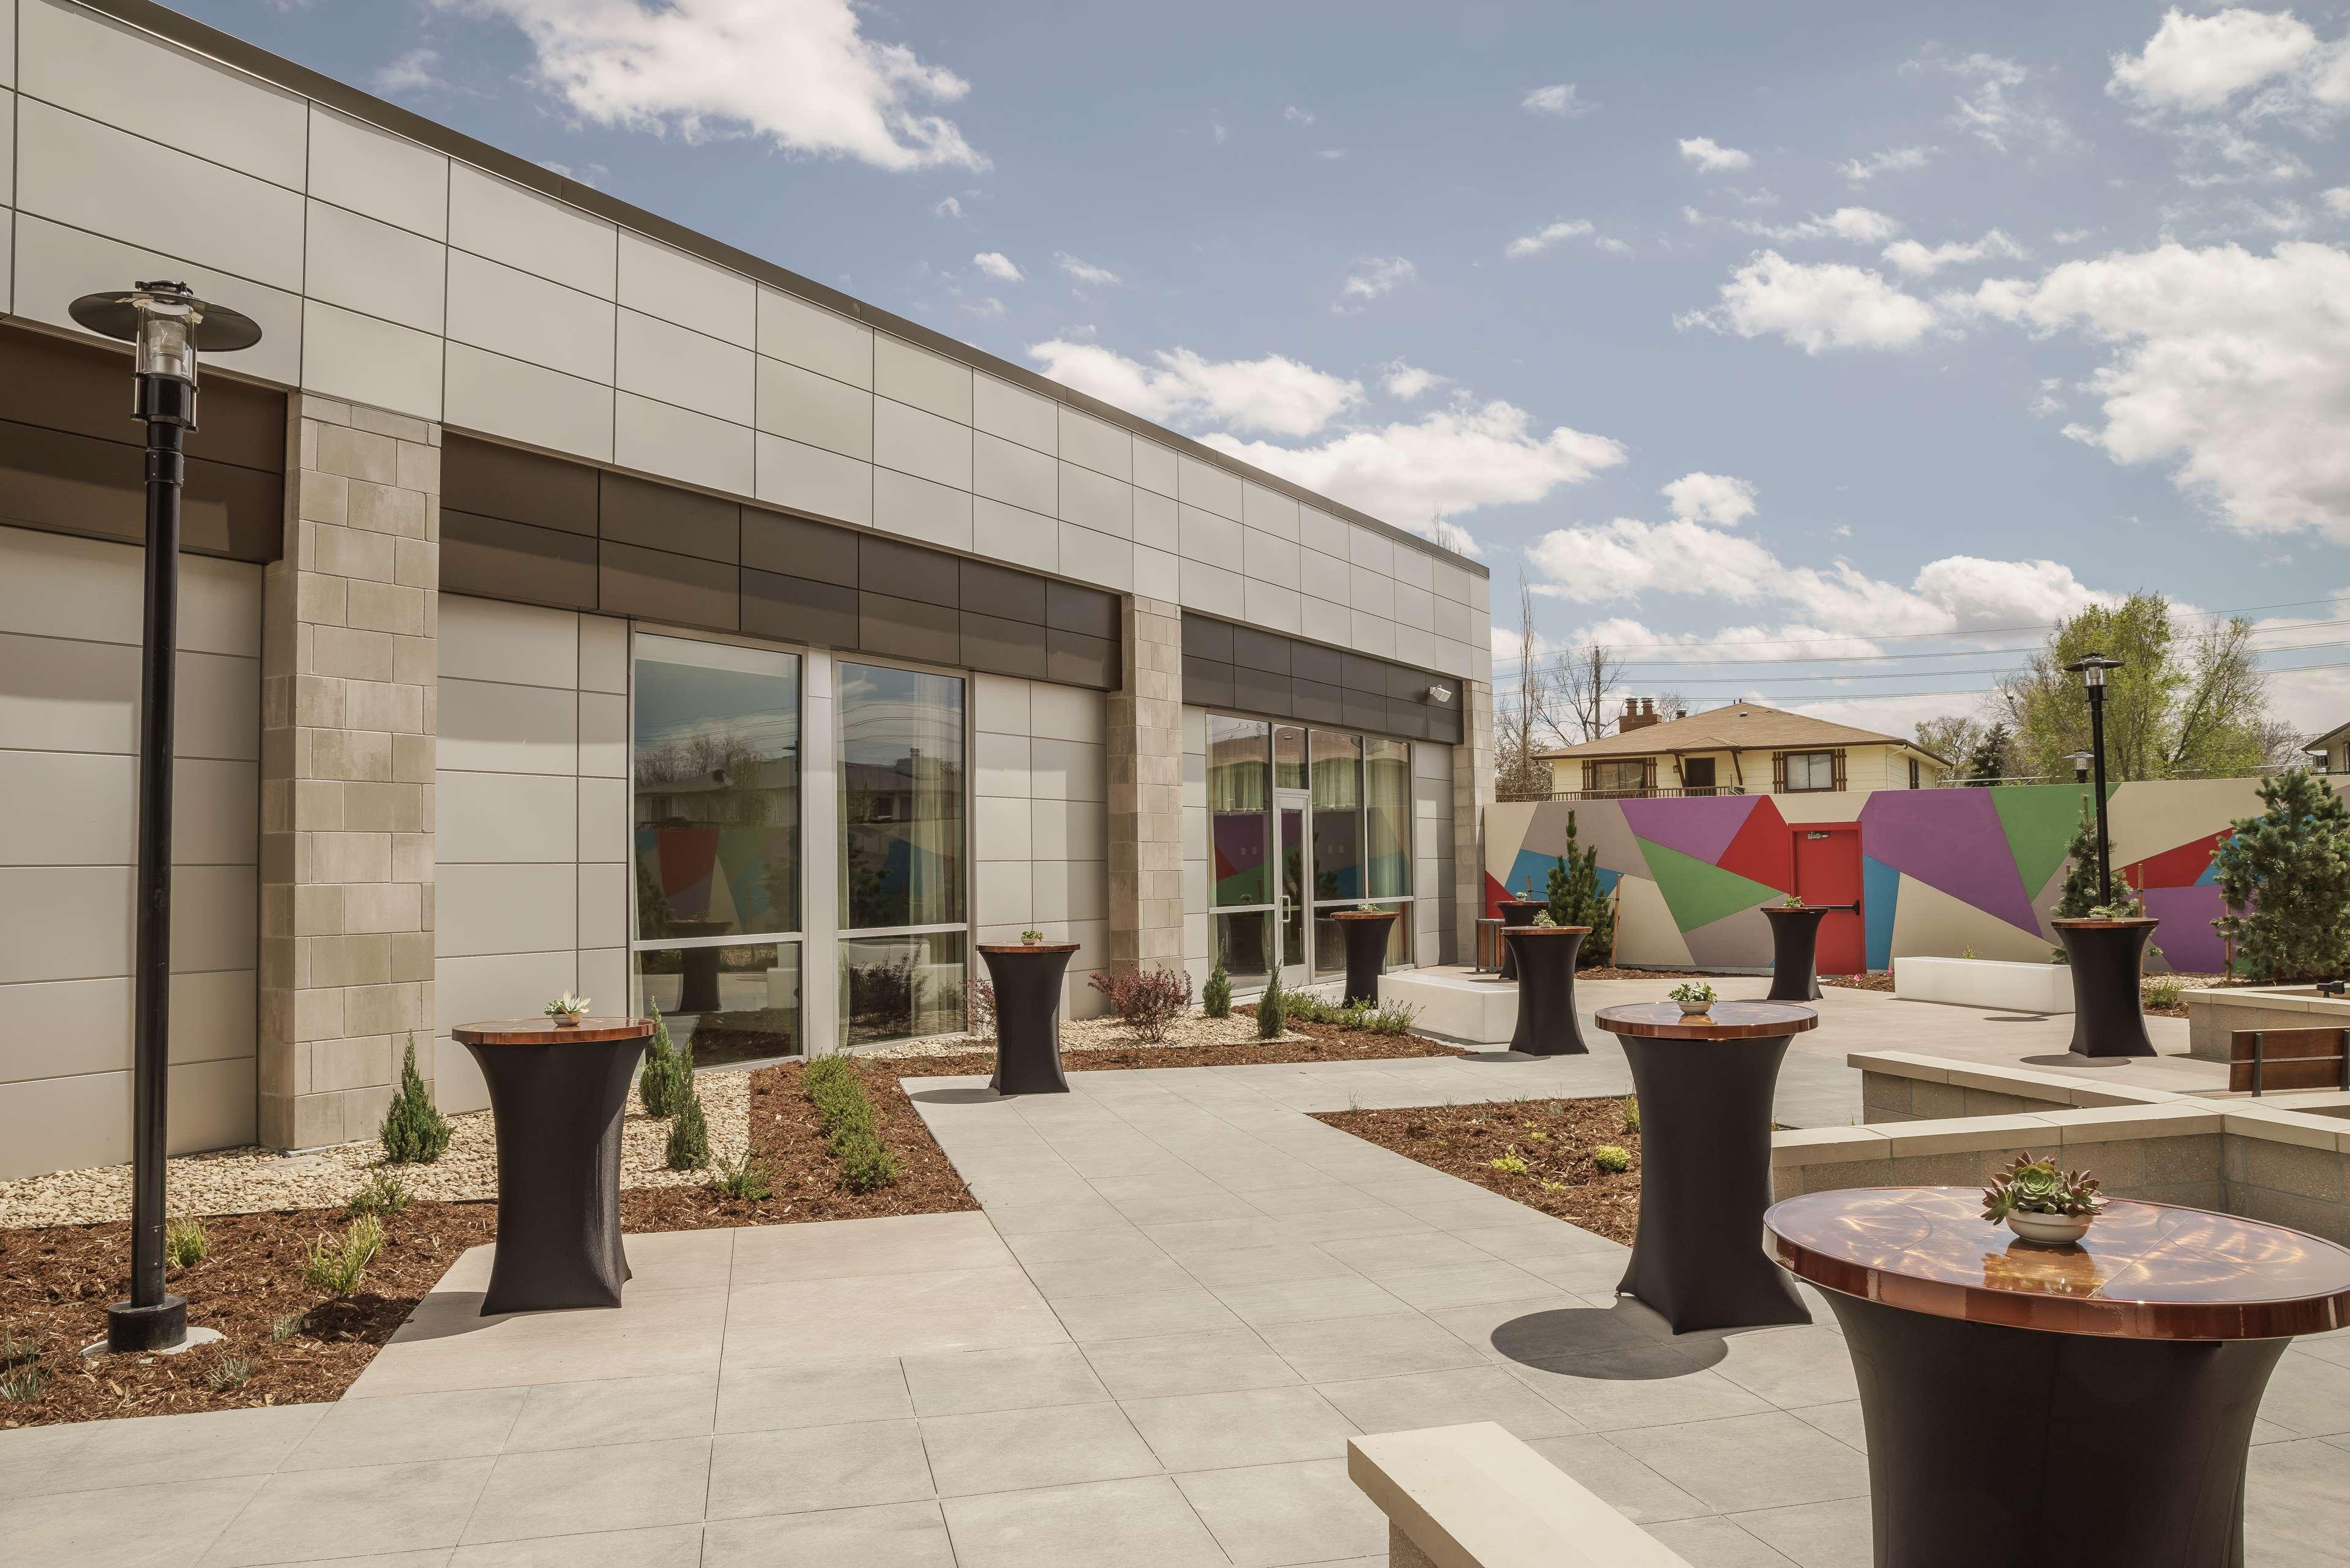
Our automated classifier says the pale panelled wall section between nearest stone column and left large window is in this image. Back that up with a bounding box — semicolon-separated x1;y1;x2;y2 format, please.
421;595;632;1110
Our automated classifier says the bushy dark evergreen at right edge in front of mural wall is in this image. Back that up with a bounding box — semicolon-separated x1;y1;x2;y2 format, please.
2211;769;2350;980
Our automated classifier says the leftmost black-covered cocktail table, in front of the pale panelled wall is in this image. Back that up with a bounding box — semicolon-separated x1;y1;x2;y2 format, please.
449;1018;653;1316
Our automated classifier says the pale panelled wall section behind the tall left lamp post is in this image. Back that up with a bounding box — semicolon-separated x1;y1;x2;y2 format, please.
0;529;261;1180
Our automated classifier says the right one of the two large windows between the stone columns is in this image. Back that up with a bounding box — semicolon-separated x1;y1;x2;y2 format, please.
839;663;968;1043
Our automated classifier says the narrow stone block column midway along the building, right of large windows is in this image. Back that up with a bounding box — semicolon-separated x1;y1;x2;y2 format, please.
1109;595;1182;971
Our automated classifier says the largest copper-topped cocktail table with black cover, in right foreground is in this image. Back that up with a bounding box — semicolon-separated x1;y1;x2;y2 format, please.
1765;1187;2350;1568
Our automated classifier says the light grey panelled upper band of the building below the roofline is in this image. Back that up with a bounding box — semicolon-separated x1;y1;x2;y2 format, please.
0;0;1492;679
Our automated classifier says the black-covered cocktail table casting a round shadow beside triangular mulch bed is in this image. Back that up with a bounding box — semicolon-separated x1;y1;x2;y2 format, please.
1596;1001;1819;1333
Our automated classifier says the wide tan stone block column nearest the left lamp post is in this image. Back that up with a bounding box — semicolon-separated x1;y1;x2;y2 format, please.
258;395;442;1149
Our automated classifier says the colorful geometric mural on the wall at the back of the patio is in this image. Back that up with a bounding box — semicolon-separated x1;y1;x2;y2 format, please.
1485;778;2261;973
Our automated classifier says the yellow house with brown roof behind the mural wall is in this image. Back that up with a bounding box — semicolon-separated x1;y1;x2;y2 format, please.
1537;698;1953;799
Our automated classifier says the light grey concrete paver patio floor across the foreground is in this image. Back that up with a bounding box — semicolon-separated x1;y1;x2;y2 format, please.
0;1042;2350;1568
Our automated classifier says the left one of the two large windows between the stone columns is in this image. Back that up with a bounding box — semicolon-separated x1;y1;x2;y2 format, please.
630;635;801;1062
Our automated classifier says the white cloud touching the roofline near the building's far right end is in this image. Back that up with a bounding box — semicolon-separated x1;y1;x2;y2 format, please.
1201;397;1626;539
